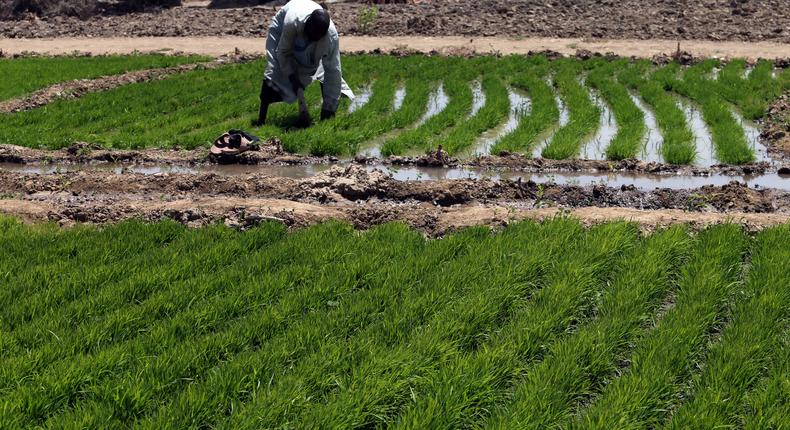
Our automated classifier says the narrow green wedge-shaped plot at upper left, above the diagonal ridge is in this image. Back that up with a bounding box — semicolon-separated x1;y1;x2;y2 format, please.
0;55;210;100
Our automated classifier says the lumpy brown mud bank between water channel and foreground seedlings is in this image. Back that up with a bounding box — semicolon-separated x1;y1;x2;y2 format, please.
0;165;790;236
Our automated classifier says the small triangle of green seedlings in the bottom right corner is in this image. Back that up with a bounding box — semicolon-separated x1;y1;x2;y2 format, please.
740;340;790;430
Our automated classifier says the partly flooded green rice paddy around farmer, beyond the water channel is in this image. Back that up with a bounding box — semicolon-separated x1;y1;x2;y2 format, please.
0;55;790;165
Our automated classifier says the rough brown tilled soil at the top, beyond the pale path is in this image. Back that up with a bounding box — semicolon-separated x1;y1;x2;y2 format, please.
0;0;790;43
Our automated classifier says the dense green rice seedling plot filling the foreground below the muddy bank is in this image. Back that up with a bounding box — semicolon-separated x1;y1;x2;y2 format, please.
0;218;790;429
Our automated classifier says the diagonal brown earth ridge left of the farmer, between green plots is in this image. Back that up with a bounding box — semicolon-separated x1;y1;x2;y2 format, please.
0;53;258;113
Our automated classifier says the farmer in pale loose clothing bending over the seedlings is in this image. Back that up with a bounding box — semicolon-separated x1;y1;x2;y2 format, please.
257;0;354;127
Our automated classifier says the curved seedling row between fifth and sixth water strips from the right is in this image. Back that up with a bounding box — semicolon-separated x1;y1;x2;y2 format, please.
491;62;560;154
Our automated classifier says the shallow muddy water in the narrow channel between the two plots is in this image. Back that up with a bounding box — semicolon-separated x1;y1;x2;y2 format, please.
0;163;790;190
